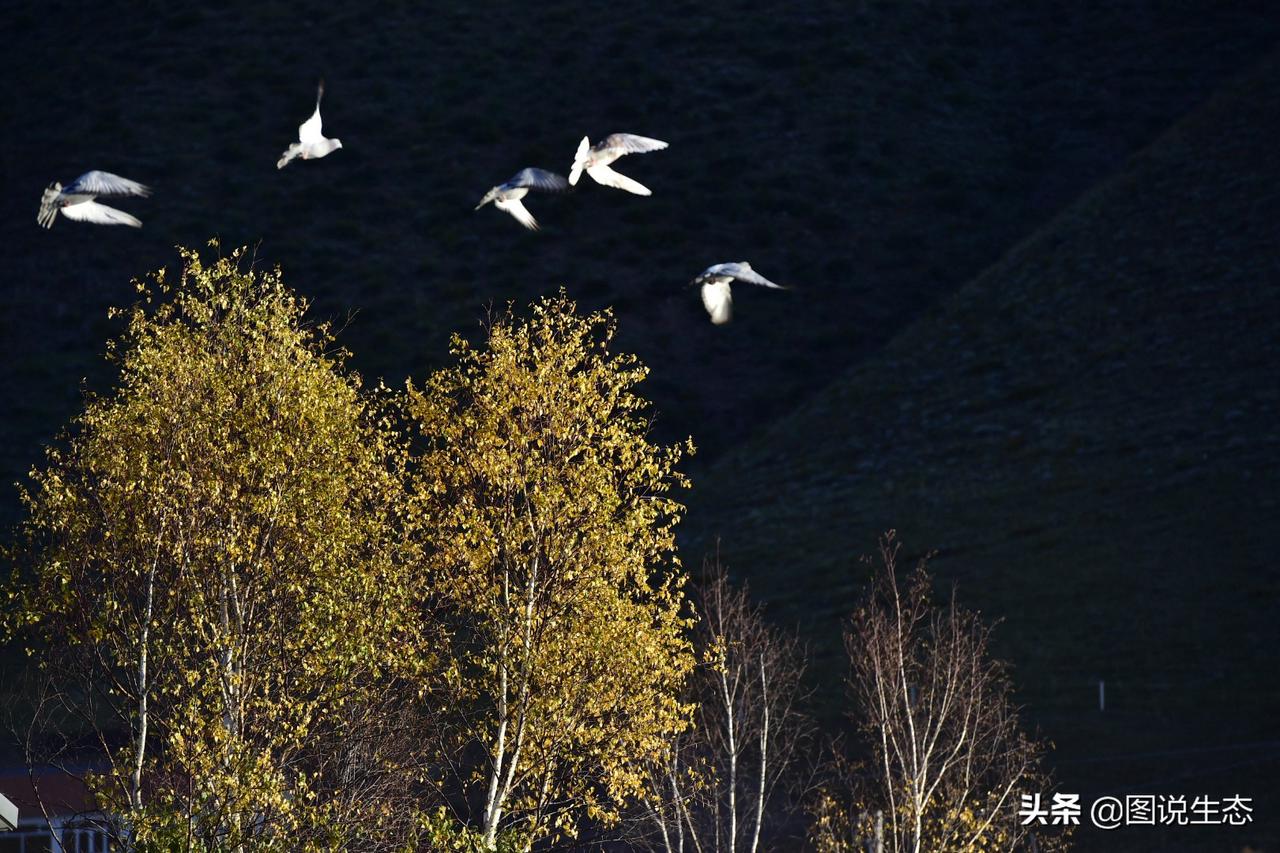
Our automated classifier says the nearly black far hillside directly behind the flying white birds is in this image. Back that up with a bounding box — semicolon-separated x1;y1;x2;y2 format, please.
0;0;1280;517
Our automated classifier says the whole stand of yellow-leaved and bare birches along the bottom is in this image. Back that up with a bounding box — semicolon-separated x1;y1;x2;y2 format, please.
4;251;1062;853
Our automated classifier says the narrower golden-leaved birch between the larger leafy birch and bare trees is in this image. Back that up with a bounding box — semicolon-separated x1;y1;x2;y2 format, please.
408;295;694;849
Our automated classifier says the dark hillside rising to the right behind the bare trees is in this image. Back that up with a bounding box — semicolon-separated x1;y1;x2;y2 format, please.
685;48;1280;850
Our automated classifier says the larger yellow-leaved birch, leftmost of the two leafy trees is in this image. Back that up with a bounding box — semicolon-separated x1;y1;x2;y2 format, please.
6;242;424;849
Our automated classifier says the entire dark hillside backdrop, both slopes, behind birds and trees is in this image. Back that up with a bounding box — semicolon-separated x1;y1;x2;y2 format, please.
0;0;1280;850
